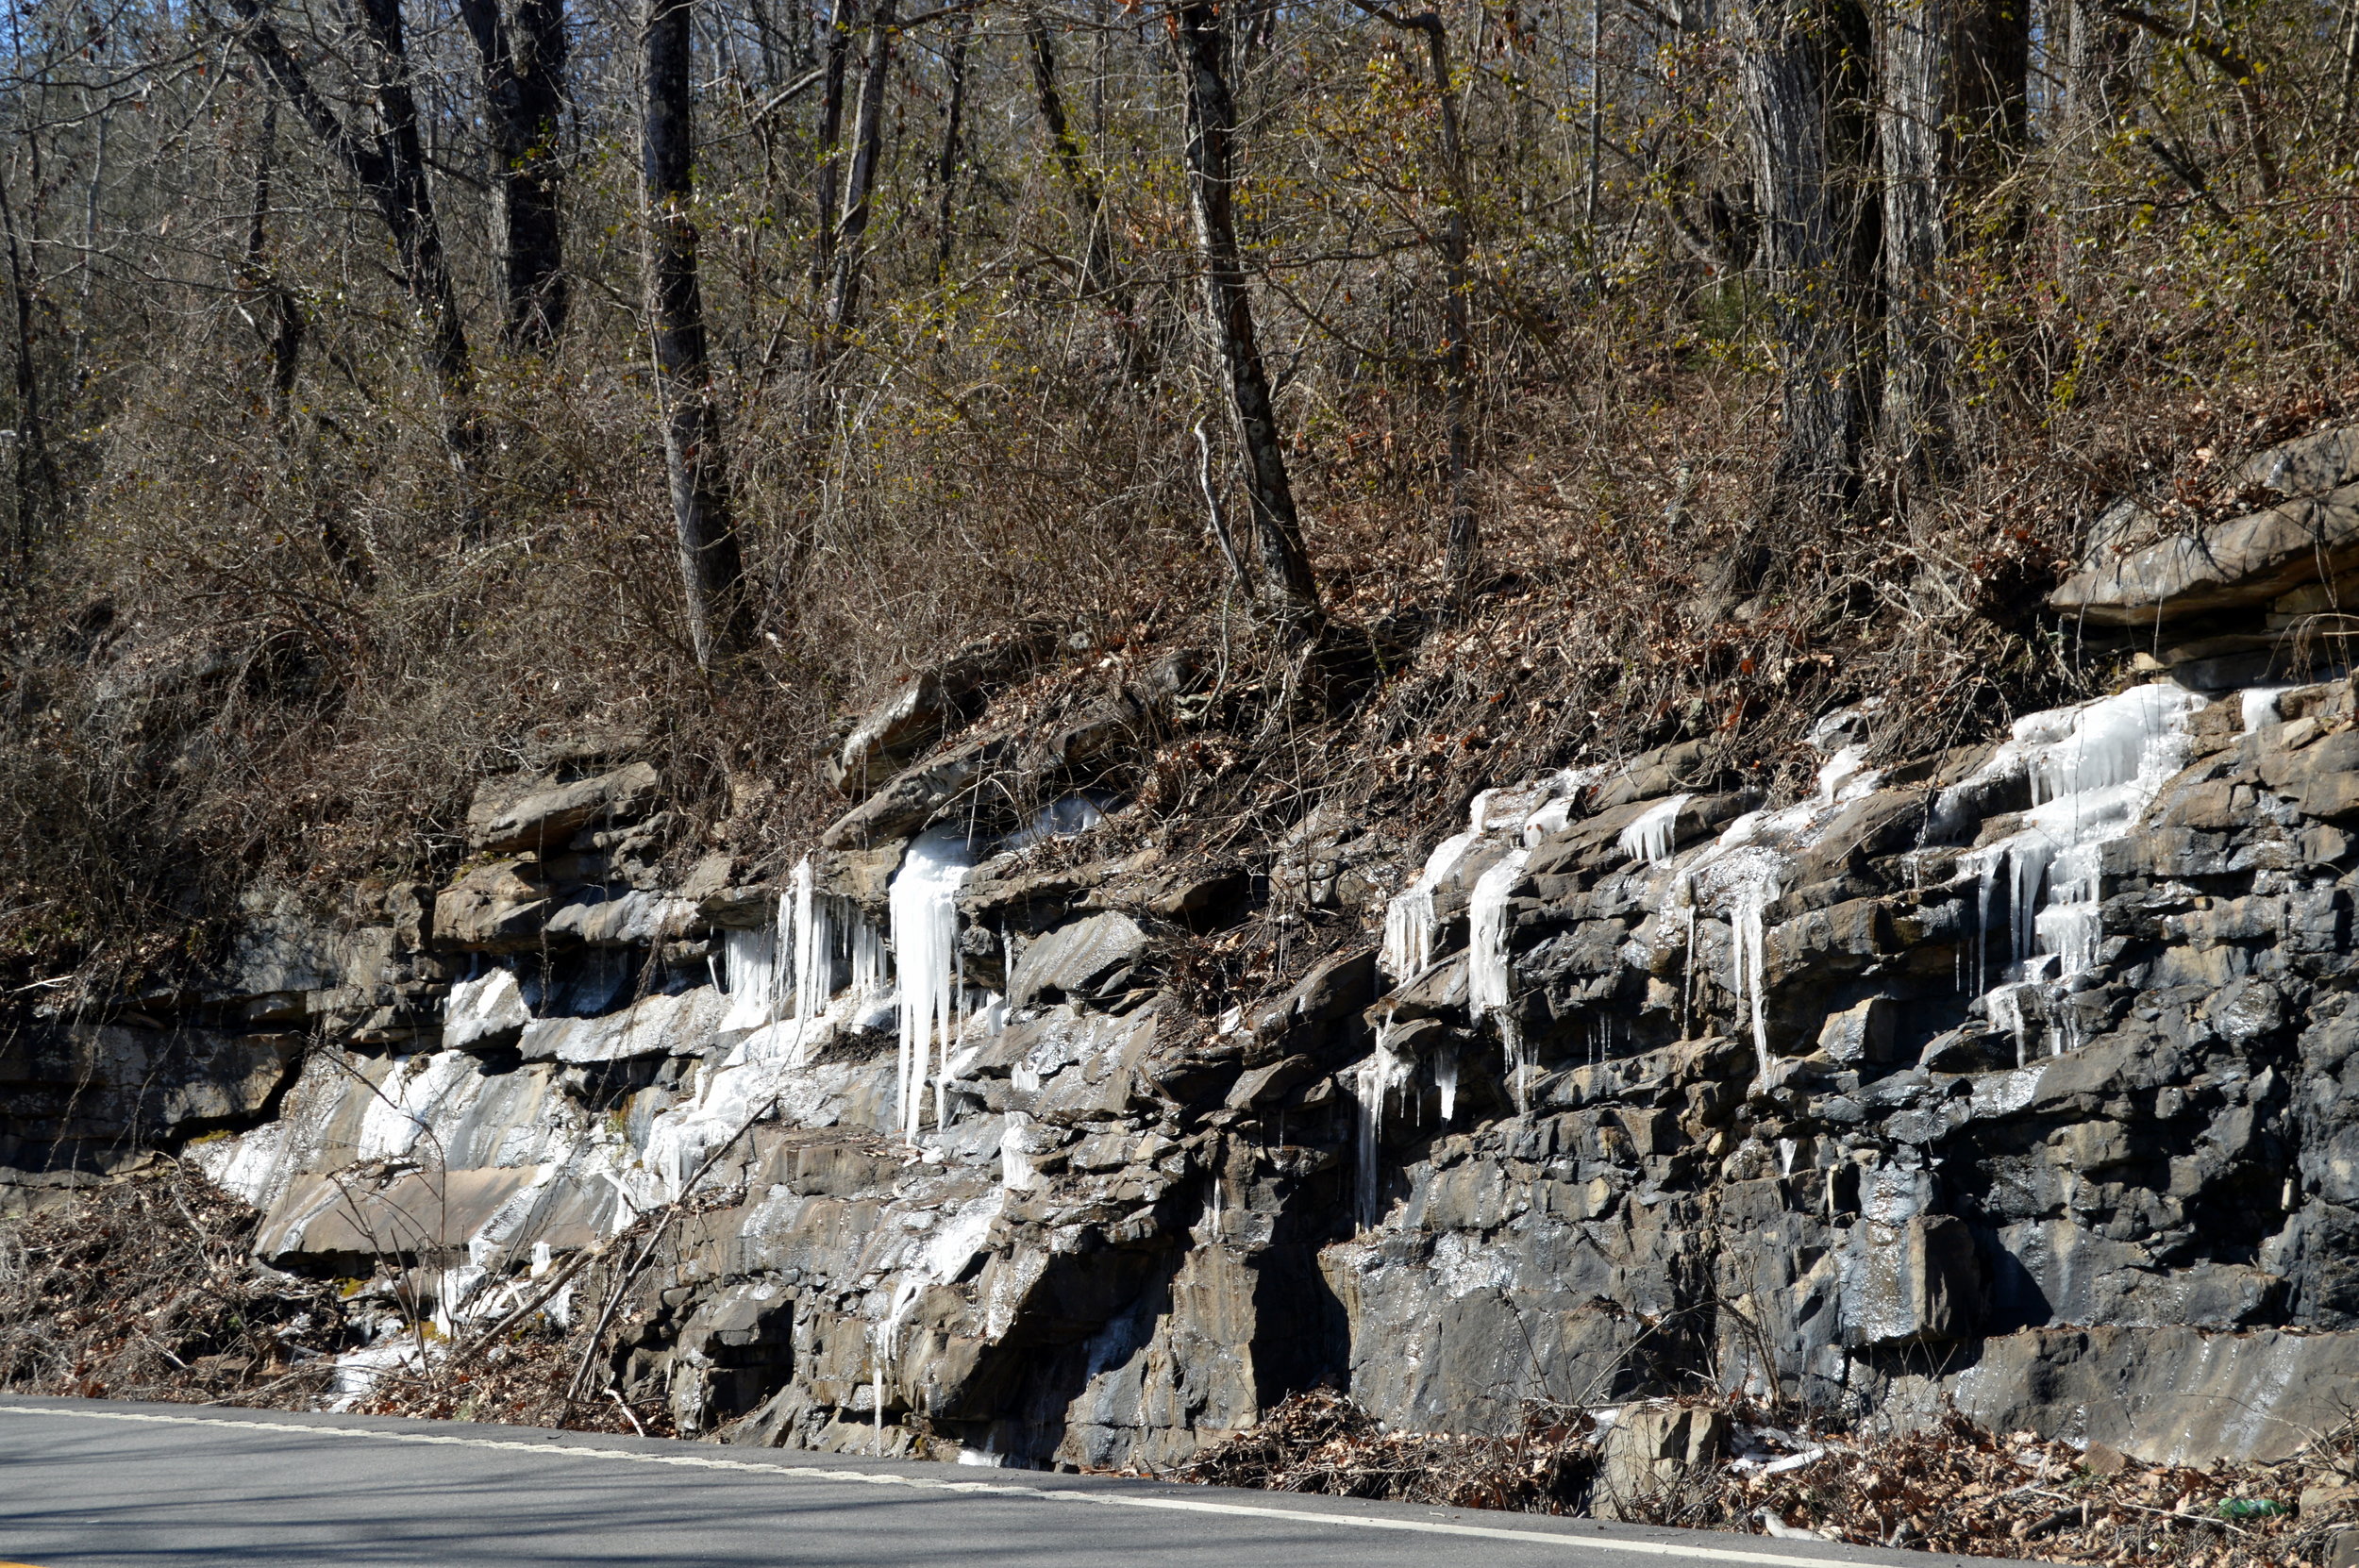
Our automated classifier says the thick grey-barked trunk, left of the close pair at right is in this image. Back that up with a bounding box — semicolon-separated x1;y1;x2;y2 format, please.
1732;0;1876;511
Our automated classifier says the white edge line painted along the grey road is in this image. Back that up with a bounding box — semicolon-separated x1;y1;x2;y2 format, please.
0;1406;1937;1568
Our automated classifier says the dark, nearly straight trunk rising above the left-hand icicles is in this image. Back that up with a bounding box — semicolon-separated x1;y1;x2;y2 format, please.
640;0;753;670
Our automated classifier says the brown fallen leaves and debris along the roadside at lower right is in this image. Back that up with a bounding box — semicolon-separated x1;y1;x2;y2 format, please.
1180;1389;2359;1568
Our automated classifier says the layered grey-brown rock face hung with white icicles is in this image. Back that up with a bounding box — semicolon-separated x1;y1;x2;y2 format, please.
23;492;2359;1467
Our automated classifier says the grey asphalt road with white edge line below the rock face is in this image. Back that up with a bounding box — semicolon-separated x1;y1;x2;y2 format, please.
0;1398;2029;1568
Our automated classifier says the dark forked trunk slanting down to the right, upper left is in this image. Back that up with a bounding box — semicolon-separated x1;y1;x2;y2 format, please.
231;0;481;466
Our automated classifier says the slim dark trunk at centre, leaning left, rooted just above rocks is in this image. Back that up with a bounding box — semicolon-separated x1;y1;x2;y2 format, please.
1170;0;1319;642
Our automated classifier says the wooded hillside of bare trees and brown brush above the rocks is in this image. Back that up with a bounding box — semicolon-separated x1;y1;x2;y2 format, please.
0;0;2359;976
